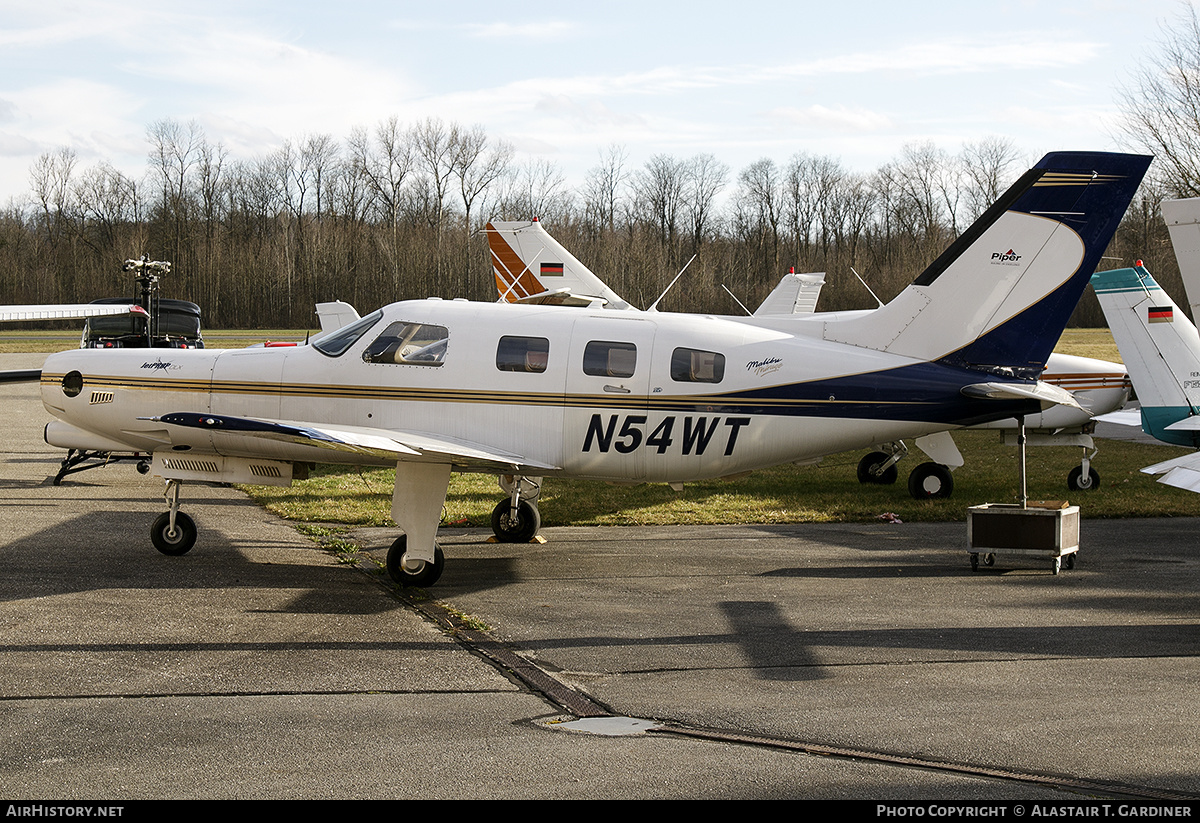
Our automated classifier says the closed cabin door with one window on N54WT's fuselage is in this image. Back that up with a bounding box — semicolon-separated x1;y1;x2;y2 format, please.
563;311;655;482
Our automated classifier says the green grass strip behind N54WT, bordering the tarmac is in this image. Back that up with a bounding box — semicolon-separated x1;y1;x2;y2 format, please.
246;431;1200;527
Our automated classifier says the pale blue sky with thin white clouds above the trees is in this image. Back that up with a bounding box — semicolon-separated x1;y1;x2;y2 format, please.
0;0;1186;204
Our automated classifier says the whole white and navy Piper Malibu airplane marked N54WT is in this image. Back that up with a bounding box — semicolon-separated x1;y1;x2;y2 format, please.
42;152;1151;585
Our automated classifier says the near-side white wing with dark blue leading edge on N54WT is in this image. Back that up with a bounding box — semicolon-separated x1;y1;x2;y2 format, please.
156;412;558;474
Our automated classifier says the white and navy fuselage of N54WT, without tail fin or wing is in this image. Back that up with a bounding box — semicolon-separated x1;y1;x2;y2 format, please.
42;300;1037;482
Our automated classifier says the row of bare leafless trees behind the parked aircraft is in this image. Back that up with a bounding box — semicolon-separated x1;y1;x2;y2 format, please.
0;118;1178;329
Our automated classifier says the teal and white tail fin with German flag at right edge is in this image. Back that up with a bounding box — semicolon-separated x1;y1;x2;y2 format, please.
1092;263;1200;446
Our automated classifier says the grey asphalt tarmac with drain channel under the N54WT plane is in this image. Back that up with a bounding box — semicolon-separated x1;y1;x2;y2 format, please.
0;355;1200;809
